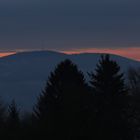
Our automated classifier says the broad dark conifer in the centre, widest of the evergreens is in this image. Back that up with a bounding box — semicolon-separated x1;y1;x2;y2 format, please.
34;60;89;139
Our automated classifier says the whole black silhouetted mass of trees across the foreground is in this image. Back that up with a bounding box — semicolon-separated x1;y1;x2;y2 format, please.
0;55;140;140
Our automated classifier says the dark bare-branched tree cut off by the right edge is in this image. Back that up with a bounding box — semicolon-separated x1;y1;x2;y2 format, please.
128;68;140;139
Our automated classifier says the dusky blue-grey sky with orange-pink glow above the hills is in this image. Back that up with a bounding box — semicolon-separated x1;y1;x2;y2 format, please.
0;0;140;60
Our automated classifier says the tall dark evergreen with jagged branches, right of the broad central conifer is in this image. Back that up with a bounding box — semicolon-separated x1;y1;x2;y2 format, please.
90;55;132;140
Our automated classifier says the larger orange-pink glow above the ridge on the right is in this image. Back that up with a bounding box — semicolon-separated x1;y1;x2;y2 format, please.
61;47;140;61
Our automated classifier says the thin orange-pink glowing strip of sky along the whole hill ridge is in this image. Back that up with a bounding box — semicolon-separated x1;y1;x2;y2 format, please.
0;47;140;62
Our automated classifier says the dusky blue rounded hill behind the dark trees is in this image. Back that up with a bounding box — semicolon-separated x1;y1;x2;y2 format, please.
0;51;140;110
